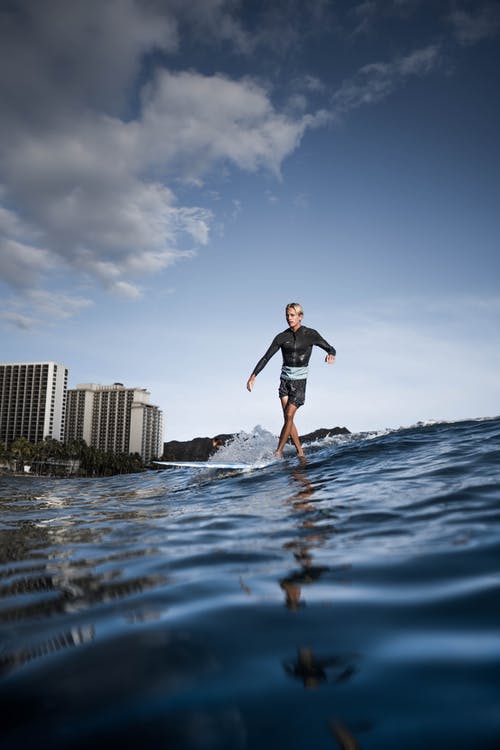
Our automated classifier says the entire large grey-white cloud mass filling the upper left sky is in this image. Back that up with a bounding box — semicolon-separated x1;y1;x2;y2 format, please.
0;0;317;318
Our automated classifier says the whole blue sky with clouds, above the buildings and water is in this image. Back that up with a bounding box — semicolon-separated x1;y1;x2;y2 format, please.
0;0;500;440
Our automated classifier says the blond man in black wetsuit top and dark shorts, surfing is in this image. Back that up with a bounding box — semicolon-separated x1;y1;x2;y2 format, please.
247;302;336;458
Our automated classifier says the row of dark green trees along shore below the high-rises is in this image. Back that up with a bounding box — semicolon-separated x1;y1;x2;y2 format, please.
0;437;145;477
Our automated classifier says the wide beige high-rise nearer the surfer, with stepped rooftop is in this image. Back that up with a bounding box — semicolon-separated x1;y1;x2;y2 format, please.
65;383;163;463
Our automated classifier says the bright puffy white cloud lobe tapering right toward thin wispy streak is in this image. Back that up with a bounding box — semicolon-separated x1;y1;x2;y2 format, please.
138;70;314;180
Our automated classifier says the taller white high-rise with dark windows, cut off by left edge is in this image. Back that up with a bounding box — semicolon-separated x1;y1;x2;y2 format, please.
0;362;68;447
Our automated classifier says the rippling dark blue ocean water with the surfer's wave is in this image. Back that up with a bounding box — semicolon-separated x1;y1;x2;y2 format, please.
0;418;500;750
